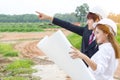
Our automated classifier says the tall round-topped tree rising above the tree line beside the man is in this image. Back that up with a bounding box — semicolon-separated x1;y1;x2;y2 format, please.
75;3;89;23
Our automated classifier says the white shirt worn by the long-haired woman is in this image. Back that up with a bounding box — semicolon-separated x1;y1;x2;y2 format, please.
89;43;116;80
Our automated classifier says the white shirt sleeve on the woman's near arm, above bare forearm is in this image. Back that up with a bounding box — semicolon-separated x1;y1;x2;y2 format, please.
90;49;111;75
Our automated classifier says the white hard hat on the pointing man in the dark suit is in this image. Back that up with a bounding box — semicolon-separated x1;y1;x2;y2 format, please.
89;6;107;18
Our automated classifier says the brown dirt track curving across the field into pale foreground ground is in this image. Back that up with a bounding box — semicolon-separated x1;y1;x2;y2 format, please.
0;30;70;80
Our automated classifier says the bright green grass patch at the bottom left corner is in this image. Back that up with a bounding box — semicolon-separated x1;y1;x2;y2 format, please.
2;59;36;80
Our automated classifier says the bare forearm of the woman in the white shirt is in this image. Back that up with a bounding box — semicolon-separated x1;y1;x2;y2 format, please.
83;55;97;71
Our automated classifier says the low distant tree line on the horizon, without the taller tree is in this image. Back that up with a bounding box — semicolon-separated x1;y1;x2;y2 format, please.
0;13;78;23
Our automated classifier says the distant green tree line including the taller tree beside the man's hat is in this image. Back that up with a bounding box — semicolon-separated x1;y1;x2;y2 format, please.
0;3;89;23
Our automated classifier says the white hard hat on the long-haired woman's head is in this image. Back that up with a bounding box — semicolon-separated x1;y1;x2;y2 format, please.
93;18;117;35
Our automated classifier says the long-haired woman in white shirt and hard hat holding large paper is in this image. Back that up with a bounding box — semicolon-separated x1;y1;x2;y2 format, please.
70;18;120;80
